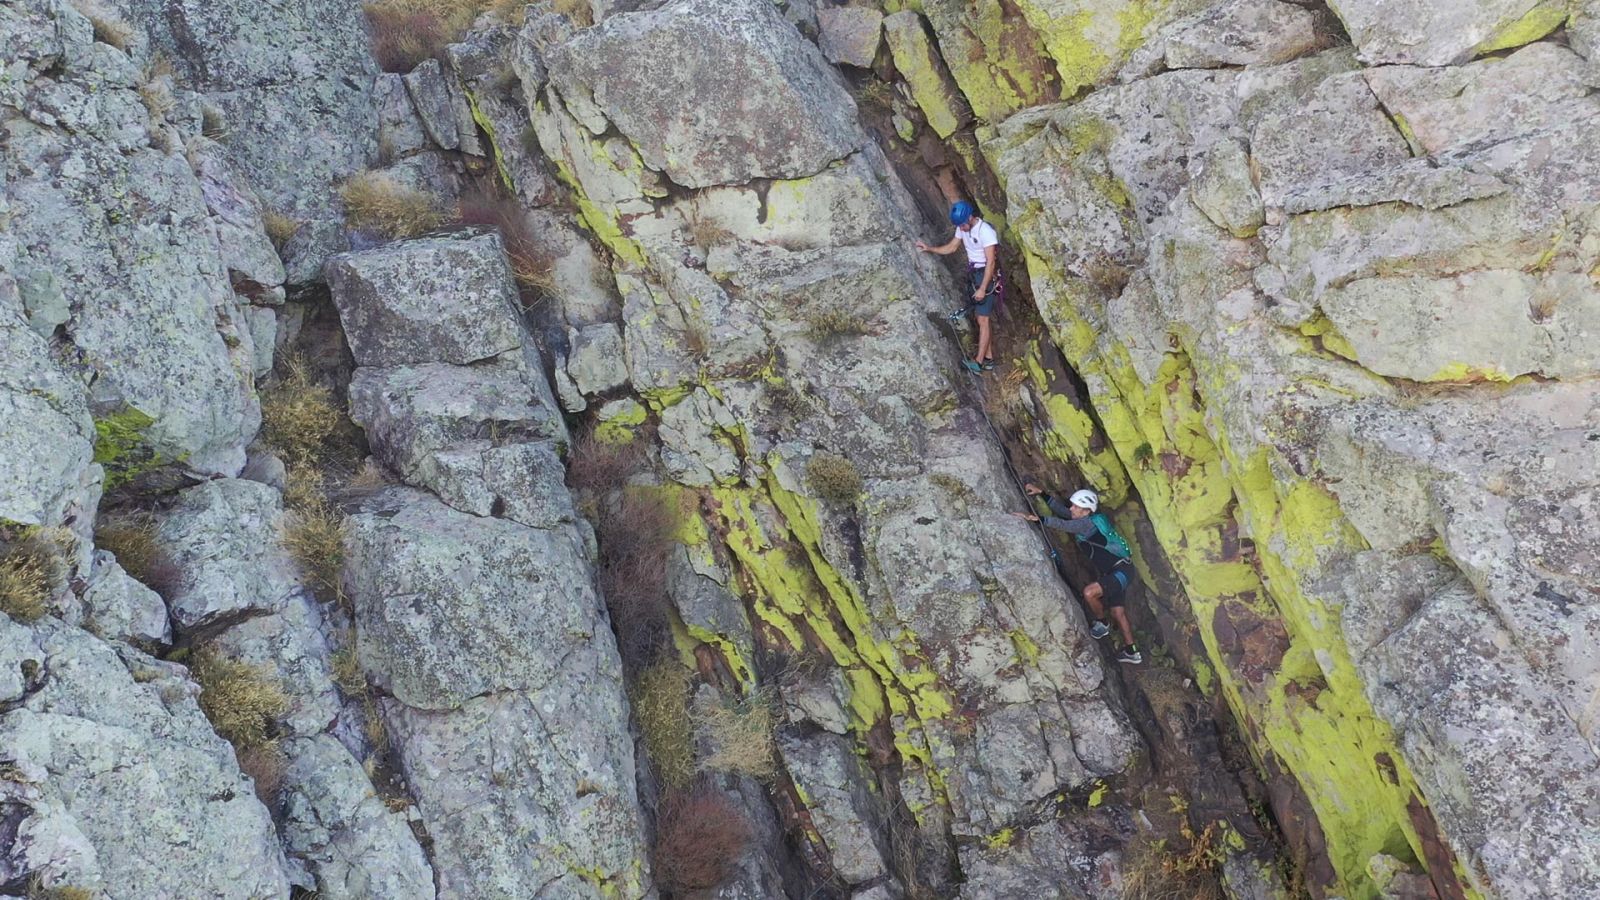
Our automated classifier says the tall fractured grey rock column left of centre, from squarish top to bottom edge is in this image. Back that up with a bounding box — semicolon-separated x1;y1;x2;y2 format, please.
328;231;650;897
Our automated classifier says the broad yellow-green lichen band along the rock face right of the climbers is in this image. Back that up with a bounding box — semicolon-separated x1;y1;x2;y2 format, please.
1027;240;1465;900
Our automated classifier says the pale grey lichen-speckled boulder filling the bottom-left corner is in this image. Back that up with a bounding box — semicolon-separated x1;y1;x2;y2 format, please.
0;617;290;900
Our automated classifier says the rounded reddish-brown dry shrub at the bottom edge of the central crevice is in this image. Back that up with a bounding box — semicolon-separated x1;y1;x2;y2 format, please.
654;786;750;894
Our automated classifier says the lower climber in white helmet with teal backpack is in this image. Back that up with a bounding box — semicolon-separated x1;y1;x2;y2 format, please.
1013;482;1144;665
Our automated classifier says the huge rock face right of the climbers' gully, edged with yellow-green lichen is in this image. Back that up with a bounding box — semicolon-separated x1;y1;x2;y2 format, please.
985;10;1600;897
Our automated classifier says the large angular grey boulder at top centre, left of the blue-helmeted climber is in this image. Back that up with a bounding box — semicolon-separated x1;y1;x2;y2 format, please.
546;0;864;187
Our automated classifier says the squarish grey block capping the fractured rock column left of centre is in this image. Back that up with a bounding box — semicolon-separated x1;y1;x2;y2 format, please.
328;231;523;365
